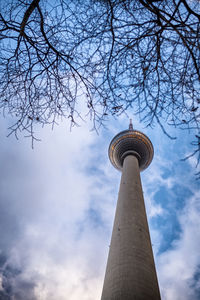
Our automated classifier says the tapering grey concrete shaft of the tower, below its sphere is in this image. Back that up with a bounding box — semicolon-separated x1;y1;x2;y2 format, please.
101;155;160;300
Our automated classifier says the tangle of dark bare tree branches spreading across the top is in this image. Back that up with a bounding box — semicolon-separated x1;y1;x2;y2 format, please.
0;0;200;173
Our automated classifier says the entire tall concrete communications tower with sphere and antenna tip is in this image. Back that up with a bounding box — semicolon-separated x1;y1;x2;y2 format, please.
101;120;160;300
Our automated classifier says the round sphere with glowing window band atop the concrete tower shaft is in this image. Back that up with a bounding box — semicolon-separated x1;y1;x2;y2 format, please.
108;130;154;171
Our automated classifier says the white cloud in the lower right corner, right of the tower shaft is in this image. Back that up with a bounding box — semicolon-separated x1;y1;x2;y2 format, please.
157;192;200;300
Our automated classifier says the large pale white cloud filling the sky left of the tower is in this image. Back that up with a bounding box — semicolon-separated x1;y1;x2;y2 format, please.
1;116;109;300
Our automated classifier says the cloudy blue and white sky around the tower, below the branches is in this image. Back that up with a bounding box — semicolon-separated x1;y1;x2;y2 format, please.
0;113;200;300
